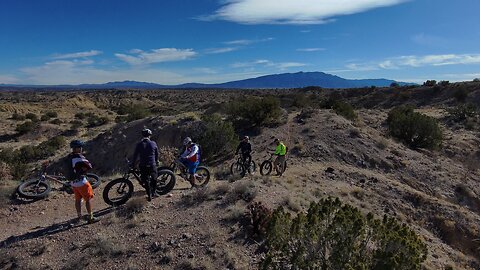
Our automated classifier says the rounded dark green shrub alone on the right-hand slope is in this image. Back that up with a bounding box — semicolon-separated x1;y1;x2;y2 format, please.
387;106;443;149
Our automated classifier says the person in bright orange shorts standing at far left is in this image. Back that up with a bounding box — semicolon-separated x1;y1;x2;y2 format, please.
67;140;98;223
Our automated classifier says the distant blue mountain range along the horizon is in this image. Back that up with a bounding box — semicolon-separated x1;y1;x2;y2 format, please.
0;72;415;89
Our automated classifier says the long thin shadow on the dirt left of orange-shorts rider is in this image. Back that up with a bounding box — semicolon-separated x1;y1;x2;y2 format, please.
0;207;115;248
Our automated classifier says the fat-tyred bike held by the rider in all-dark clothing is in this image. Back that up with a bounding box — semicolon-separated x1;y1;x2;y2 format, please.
103;159;176;206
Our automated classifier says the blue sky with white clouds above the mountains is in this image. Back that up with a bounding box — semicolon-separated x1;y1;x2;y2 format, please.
0;0;480;85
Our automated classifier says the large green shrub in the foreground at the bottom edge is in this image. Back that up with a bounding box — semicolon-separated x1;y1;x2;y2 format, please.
261;198;427;269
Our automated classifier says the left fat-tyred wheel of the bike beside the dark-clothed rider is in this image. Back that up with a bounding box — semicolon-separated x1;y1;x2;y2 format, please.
103;178;133;206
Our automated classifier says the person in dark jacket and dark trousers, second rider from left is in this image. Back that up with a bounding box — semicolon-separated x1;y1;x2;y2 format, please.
132;128;158;201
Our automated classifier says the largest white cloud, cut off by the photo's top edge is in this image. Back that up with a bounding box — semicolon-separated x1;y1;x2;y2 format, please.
200;0;408;24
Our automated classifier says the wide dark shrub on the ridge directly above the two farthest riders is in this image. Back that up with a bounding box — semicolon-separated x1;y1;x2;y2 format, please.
227;96;281;127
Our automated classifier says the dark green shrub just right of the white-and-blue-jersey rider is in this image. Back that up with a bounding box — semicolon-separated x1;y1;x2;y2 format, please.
191;114;238;161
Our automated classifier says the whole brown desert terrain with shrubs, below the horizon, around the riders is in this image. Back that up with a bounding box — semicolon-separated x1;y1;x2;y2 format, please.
0;81;480;269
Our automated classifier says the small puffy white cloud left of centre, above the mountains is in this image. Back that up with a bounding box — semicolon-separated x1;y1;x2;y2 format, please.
115;48;197;65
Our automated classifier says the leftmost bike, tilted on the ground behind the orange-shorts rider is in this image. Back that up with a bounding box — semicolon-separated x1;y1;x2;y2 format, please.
17;162;101;199
